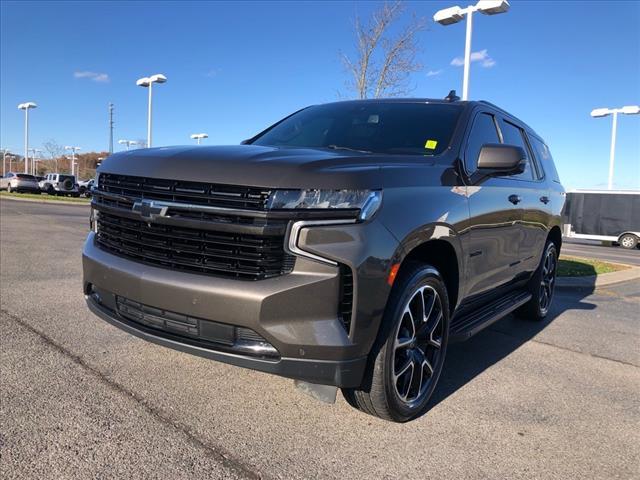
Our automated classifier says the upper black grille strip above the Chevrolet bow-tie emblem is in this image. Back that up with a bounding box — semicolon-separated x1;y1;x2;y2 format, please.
98;173;271;211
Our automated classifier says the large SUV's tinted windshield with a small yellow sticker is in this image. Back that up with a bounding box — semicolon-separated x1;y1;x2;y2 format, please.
252;102;462;155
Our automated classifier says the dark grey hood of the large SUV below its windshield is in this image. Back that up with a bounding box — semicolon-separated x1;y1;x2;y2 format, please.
99;145;396;189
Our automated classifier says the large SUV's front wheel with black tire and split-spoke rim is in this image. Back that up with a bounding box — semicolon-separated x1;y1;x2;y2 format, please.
342;263;449;422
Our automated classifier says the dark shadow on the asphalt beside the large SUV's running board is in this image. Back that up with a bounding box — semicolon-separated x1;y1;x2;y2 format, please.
429;283;596;408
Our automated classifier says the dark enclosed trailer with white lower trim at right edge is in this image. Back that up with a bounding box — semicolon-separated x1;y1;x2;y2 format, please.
563;190;640;249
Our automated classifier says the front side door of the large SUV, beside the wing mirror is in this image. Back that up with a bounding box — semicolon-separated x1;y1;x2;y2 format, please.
464;112;522;301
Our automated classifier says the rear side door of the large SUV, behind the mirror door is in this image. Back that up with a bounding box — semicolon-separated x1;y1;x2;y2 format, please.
499;117;551;274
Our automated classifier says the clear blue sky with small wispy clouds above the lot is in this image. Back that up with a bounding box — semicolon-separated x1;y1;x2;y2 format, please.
0;0;640;189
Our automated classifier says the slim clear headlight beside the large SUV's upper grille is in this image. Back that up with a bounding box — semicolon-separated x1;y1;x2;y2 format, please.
267;189;382;220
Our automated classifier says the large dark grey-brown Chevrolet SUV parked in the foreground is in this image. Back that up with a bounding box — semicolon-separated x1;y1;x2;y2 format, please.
83;97;564;422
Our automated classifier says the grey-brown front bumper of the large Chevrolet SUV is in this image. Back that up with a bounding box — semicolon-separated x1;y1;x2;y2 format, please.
83;221;396;387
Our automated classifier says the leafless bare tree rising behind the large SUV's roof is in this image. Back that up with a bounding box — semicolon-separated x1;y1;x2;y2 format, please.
342;1;426;98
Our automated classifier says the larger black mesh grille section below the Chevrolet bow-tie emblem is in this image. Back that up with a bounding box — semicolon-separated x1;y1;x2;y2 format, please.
96;212;295;280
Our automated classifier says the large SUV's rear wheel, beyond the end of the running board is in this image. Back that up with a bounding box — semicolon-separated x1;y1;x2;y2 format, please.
515;240;558;321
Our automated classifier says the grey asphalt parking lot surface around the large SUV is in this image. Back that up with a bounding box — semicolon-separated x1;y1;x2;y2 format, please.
0;200;640;479
